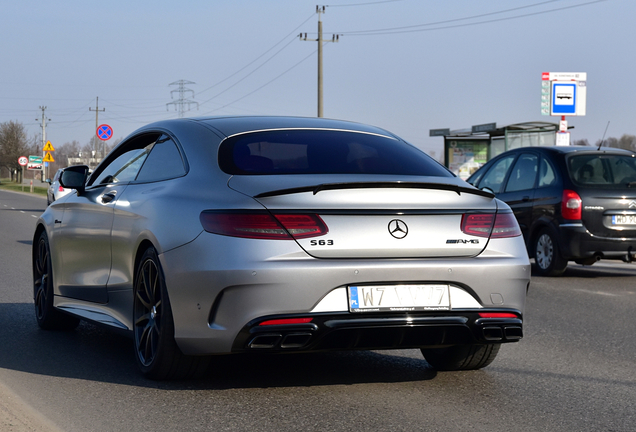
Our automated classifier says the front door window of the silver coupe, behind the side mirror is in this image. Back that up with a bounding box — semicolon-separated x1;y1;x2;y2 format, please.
88;133;161;186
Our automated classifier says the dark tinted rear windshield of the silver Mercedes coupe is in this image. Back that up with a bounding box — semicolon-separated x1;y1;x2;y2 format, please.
219;130;453;177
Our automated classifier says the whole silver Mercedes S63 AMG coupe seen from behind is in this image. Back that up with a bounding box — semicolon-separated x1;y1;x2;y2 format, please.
33;116;530;379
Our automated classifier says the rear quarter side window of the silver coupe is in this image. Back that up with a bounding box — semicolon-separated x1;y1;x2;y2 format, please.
137;135;185;182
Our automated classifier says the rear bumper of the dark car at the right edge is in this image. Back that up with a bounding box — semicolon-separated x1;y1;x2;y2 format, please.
559;224;636;260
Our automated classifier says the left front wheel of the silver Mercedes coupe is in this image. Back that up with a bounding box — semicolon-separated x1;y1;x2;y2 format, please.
32;231;80;330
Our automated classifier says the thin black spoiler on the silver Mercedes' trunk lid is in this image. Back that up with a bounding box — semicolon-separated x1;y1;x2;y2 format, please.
255;181;495;198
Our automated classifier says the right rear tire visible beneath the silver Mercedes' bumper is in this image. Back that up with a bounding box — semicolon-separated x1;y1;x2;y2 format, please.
421;344;501;371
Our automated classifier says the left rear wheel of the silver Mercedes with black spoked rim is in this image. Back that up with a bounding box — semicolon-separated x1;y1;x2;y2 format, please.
133;247;209;380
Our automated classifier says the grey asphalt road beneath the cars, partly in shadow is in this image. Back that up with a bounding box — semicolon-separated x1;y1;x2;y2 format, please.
0;191;636;432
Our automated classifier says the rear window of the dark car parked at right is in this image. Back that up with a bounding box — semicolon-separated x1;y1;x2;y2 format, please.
568;154;636;187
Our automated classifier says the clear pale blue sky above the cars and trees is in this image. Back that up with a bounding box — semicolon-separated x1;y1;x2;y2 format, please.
0;0;636;158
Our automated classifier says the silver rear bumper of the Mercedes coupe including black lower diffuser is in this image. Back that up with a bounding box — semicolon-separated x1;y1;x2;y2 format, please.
160;234;530;355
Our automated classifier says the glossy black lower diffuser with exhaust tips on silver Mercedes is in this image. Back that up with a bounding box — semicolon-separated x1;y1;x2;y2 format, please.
232;311;523;352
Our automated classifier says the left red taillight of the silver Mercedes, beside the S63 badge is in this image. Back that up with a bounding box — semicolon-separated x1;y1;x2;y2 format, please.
199;210;329;240
